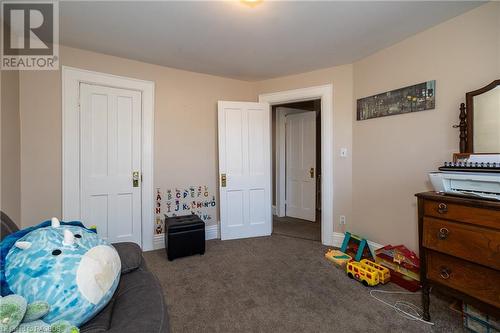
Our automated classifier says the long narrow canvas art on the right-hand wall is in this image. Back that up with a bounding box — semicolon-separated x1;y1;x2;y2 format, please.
356;80;436;120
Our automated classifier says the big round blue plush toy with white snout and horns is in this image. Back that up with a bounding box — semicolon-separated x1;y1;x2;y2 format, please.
0;218;121;326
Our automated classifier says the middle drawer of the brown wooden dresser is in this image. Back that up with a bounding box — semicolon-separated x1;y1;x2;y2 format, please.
423;217;500;268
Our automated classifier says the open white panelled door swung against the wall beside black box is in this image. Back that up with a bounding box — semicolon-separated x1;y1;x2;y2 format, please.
218;101;272;240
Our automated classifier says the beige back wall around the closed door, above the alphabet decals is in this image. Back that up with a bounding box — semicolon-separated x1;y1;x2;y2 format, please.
20;47;254;226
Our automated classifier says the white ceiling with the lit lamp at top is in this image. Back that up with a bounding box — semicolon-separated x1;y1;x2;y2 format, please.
60;0;482;81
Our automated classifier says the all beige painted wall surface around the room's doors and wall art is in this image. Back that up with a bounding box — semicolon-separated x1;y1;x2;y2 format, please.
15;3;500;250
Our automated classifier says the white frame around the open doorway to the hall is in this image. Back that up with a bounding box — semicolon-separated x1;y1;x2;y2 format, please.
259;84;334;245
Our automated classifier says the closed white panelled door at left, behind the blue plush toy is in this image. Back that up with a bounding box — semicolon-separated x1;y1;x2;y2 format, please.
80;83;142;244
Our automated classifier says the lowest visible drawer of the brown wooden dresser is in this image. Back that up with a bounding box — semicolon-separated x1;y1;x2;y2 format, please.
426;251;500;307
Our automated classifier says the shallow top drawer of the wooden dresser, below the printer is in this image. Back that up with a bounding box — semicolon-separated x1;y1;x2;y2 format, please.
424;200;500;229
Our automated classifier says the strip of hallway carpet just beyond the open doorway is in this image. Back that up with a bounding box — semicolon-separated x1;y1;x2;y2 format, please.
273;216;321;241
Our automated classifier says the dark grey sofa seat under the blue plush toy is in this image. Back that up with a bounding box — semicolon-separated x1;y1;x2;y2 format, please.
0;212;169;333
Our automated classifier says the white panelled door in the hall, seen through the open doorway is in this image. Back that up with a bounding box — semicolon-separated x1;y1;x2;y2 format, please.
286;112;316;221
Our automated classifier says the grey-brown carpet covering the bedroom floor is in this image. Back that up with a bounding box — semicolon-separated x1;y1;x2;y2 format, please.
144;235;463;333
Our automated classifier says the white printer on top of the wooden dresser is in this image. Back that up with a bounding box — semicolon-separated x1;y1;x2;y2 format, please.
429;155;500;200
